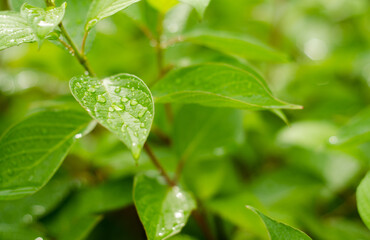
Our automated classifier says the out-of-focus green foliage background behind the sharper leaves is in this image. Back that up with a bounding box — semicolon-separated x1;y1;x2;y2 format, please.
0;0;370;240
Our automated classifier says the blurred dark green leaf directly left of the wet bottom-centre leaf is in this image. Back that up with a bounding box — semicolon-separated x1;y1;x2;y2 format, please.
46;179;133;240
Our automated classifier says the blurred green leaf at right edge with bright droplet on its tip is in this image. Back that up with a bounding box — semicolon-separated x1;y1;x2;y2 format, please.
329;108;370;146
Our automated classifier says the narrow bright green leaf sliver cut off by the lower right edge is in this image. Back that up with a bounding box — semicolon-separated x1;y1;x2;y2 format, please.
356;172;370;229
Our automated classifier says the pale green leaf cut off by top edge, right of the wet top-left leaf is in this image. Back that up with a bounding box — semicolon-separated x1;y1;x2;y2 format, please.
85;0;140;31
